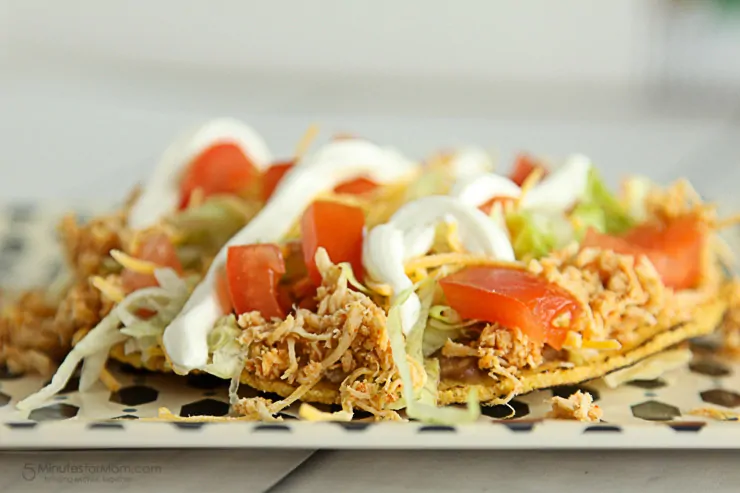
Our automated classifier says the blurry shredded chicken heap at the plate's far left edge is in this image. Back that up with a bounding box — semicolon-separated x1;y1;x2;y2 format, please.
0;280;112;376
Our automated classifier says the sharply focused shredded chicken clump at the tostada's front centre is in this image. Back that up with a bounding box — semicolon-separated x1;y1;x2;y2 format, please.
234;250;400;419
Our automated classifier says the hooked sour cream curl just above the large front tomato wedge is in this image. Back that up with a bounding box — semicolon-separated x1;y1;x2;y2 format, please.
362;196;514;333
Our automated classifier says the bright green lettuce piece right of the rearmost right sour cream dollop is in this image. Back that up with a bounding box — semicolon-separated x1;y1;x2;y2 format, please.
570;168;635;236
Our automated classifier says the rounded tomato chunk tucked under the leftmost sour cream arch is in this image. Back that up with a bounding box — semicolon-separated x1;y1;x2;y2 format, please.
180;142;258;207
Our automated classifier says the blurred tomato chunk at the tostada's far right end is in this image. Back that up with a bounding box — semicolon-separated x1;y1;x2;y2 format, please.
581;216;707;289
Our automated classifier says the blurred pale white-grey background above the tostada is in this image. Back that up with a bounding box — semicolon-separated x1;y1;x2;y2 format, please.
0;0;740;205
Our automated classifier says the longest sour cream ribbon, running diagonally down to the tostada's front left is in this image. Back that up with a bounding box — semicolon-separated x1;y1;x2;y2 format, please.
164;139;416;373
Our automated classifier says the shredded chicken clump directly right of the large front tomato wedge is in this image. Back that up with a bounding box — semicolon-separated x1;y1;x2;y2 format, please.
529;246;690;344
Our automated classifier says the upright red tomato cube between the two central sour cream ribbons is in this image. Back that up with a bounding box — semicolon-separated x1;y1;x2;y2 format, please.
301;201;365;286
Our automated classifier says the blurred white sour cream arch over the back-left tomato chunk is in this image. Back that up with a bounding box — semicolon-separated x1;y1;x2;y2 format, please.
128;118;273;229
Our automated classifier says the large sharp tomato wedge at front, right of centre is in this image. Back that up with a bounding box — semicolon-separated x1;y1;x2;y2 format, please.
439;266;581;349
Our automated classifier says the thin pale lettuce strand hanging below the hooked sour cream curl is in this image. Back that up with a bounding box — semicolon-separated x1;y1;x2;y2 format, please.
387;289;480;424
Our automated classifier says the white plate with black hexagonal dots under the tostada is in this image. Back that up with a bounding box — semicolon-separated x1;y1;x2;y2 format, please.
0;205;740;449
